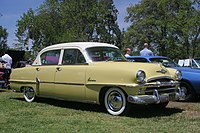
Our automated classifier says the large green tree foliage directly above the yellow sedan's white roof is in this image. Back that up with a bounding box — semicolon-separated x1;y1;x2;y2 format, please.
16;0;121;51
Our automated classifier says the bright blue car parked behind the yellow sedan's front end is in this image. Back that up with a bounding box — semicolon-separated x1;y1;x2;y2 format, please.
127;56;200;101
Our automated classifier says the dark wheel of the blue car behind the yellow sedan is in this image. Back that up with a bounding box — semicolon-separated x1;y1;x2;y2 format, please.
180;82;196;101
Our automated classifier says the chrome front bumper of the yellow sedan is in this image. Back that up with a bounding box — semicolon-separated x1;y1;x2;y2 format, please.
127;89;182;104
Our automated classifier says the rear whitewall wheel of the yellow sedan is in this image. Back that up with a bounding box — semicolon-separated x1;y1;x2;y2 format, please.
24;87;36;102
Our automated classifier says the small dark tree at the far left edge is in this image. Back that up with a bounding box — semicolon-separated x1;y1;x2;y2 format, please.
0;26;8;49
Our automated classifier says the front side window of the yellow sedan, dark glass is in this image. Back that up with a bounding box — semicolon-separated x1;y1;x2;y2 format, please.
62;49;86;65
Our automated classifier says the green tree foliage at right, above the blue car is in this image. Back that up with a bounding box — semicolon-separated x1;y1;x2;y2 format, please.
124;0;200;58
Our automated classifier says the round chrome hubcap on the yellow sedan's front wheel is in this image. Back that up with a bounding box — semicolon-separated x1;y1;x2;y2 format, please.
107;91;123;111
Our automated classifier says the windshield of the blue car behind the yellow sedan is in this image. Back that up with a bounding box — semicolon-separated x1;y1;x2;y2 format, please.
149;58;179;67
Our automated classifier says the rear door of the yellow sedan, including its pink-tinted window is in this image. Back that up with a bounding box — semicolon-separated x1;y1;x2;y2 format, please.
35;49;61;97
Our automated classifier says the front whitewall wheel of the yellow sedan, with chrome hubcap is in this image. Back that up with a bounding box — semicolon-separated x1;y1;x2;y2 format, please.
104;88;130;115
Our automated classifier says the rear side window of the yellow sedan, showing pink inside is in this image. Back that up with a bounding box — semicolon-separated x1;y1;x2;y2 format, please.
40;50;60;65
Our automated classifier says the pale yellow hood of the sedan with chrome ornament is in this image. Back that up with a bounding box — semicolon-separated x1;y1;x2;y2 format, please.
91;61;176;80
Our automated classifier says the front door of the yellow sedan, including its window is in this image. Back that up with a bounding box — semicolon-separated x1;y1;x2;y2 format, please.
55;48;88;100
